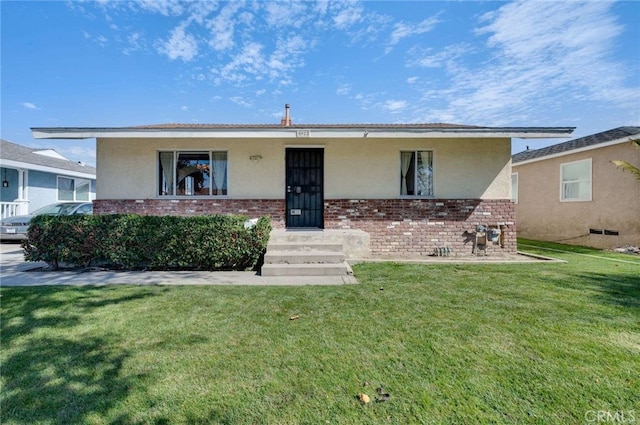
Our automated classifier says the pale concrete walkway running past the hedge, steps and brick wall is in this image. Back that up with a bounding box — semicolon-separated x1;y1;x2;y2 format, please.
0;243;545;286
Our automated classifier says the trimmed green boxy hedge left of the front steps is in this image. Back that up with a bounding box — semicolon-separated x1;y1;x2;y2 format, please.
23;214;271;271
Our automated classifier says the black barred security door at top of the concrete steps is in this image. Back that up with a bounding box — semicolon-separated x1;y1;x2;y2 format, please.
286;148;324;229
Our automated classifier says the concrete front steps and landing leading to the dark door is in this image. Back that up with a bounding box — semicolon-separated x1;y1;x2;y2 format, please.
261;229;368;283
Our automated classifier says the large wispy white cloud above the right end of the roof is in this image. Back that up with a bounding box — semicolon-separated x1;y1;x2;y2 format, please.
411;0;640;125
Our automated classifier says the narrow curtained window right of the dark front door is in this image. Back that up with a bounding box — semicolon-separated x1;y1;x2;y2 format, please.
400;151;433;196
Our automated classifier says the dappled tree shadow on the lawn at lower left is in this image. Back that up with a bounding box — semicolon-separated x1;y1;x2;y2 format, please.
0;287;157;424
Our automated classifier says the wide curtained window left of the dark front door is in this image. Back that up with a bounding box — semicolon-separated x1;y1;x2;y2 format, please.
158;151;227;196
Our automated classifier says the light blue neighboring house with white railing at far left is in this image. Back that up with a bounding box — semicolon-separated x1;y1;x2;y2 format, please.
0;140;96;218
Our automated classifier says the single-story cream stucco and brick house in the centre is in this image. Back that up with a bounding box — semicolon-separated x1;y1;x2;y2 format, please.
32;107;573;256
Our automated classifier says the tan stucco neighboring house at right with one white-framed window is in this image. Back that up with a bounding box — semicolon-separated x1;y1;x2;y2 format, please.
512;127;640;249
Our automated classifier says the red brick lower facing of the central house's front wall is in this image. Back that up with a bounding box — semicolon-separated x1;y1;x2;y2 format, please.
94;199;516;256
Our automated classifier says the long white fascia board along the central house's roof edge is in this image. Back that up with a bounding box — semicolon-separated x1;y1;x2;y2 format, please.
32;126;573;139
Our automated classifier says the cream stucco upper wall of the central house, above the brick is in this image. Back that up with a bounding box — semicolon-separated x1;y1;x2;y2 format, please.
97;138;511;199
